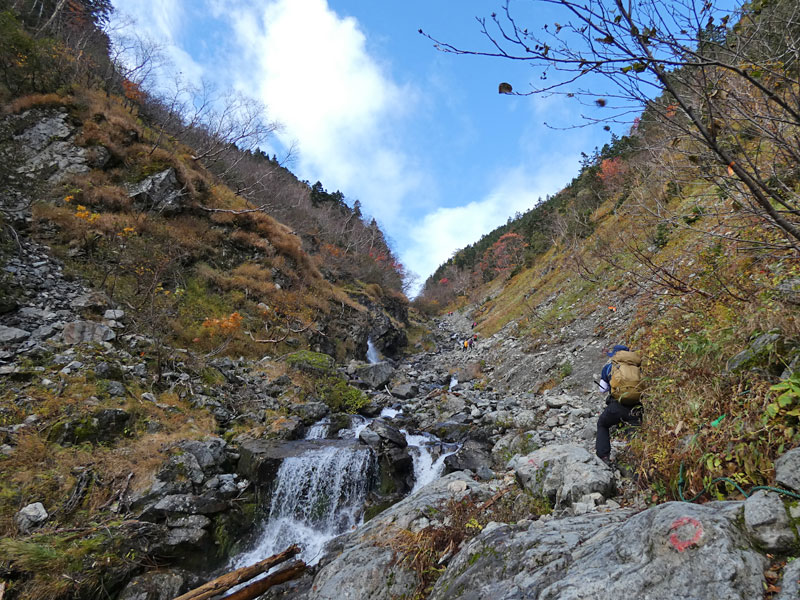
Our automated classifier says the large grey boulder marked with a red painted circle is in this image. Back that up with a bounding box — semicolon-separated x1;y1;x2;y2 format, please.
430;502;767;600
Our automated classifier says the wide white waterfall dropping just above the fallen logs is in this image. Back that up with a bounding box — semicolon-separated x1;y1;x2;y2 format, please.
234;422;375;567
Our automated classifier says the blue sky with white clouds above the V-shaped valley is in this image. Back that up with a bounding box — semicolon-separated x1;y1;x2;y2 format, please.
113;0;624;290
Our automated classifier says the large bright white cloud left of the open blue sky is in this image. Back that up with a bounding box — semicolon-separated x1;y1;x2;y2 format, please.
231;0;420;221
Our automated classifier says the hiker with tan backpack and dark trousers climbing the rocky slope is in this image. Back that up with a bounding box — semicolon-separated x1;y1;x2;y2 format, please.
595;344;642;464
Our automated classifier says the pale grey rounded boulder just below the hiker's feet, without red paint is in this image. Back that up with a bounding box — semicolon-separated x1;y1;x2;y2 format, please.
508;444;614;506
